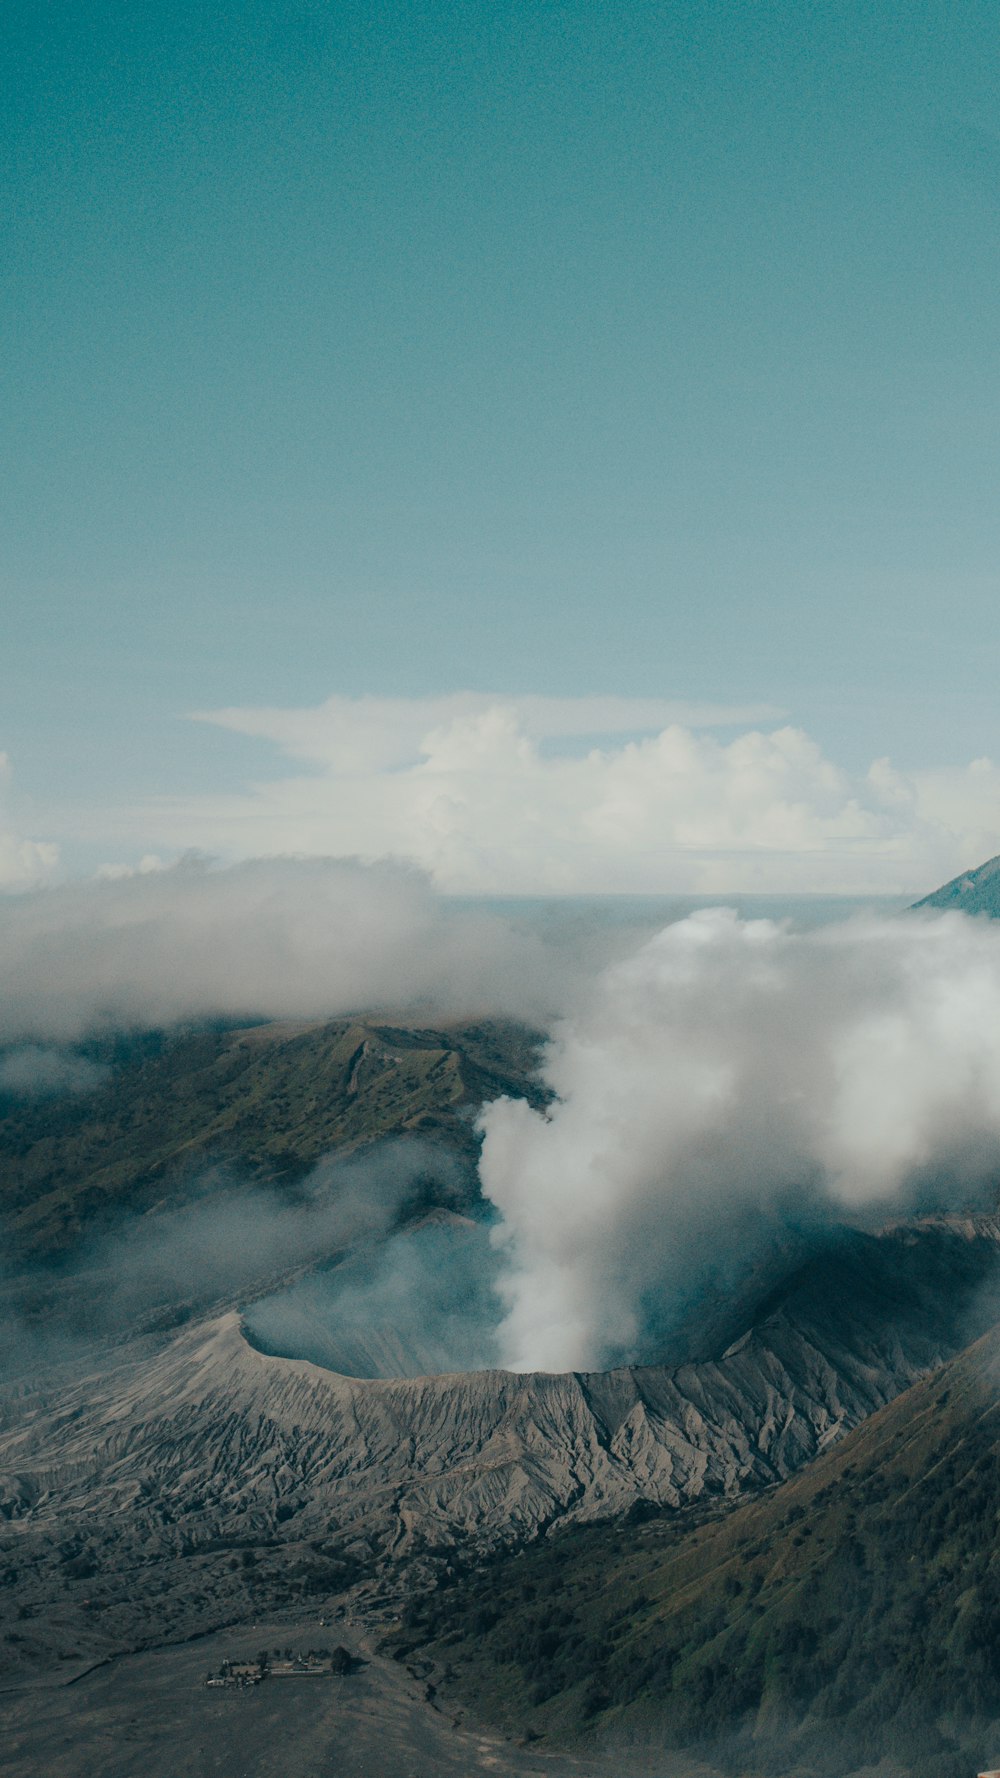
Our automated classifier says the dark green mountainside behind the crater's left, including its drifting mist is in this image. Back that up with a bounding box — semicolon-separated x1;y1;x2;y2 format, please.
0;1019;544;1378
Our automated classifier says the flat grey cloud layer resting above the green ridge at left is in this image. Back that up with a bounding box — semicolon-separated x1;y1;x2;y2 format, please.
0;859;568;1045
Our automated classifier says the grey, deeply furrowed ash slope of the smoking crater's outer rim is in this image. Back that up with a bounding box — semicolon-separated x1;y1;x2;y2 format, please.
0;1220;1000;1685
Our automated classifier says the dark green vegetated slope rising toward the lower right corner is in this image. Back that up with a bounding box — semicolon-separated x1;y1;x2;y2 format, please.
404;1328;1000;1778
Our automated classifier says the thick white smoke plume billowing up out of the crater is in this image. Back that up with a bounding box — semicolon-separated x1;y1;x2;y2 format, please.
480;910;1000;1371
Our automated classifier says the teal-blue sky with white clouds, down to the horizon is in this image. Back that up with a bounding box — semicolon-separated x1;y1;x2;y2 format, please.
0;0;1000;894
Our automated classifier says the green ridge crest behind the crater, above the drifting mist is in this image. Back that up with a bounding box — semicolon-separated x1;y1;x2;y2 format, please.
0;1019;539;1259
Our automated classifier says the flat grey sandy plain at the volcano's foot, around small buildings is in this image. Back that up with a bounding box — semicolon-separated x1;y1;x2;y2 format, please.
0;1613;721;1778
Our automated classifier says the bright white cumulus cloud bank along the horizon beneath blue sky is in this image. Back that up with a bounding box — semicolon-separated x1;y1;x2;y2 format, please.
103;693;1000;894
